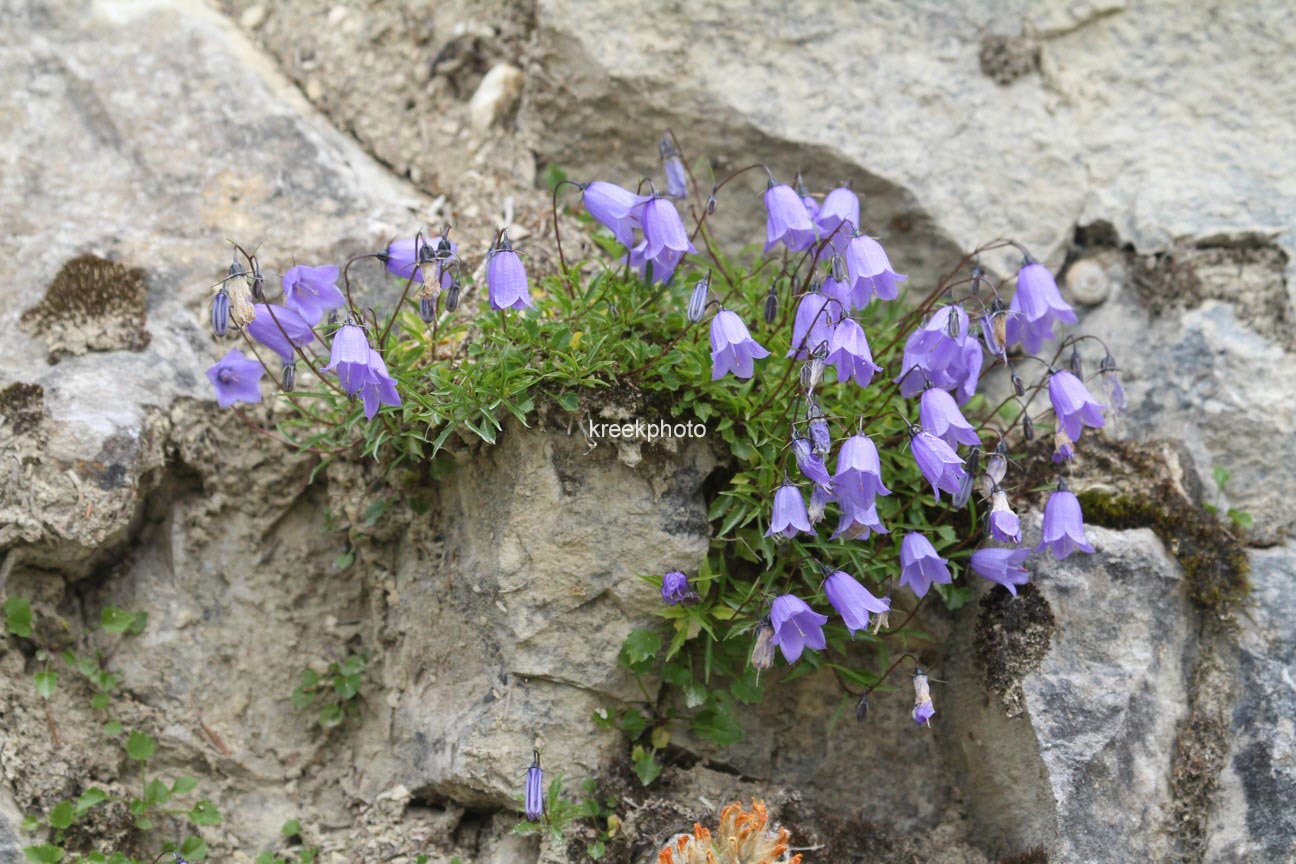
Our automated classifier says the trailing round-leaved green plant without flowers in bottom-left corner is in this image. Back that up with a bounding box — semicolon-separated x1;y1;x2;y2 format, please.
4;597;222;864
